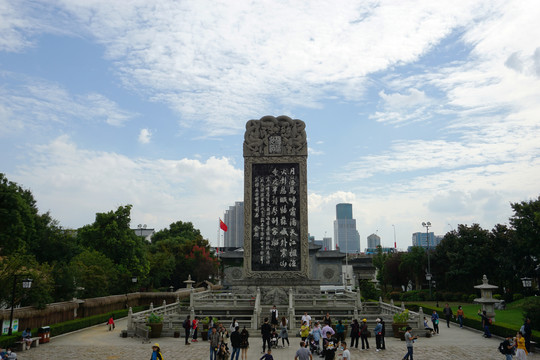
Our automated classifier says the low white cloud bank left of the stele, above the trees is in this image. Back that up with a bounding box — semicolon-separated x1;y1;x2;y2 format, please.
8;136;243;240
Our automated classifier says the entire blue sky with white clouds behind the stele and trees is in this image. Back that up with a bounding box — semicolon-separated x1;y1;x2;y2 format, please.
0;0;540;248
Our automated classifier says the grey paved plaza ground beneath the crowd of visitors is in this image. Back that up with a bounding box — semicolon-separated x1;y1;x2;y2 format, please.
18;319;540;360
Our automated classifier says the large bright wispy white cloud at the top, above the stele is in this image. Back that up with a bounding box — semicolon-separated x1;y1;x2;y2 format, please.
39;0;491;135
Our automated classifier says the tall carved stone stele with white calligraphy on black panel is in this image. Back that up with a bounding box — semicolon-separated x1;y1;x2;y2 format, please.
241;116;313;286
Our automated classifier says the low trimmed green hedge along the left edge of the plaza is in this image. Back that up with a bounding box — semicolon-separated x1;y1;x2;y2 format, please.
0;306;148;349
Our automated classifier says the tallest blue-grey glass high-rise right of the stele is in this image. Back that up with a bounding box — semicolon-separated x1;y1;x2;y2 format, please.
334;204;360;253
